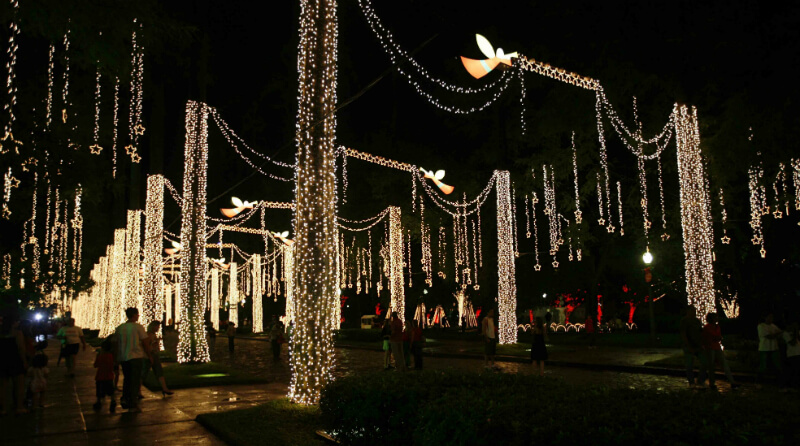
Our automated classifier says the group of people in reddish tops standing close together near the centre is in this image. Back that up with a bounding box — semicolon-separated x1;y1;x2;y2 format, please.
381;311;425;372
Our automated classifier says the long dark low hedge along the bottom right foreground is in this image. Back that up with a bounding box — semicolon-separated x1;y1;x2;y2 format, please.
320;371;800;446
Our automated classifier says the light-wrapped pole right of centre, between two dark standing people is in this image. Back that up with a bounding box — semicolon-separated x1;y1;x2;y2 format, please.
495;171;517;344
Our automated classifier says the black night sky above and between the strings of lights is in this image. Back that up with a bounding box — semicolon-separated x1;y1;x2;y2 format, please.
3;0;800;320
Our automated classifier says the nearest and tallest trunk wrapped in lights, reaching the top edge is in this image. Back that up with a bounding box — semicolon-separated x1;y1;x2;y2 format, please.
289;0;339;404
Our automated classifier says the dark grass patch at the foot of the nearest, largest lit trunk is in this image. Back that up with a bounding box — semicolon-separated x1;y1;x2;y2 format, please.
197;398;327;446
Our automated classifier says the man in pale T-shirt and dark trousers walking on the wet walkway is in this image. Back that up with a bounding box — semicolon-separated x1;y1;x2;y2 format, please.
115;307;150;413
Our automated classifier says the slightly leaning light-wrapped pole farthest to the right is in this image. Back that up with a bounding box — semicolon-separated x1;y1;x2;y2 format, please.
674;104;715;314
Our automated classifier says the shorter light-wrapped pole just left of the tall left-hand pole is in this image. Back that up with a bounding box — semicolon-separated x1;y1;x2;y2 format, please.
142;175;164;322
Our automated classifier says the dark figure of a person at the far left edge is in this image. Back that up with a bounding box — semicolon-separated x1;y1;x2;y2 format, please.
0;309;28;415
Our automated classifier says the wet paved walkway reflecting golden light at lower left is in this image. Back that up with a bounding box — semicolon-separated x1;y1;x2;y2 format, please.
0;339;286;446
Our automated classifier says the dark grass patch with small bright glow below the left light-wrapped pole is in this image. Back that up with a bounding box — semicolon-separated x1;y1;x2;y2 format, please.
144;362;269;390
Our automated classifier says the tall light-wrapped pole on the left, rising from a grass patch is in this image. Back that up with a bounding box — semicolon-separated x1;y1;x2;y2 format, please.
175;101;210;363
